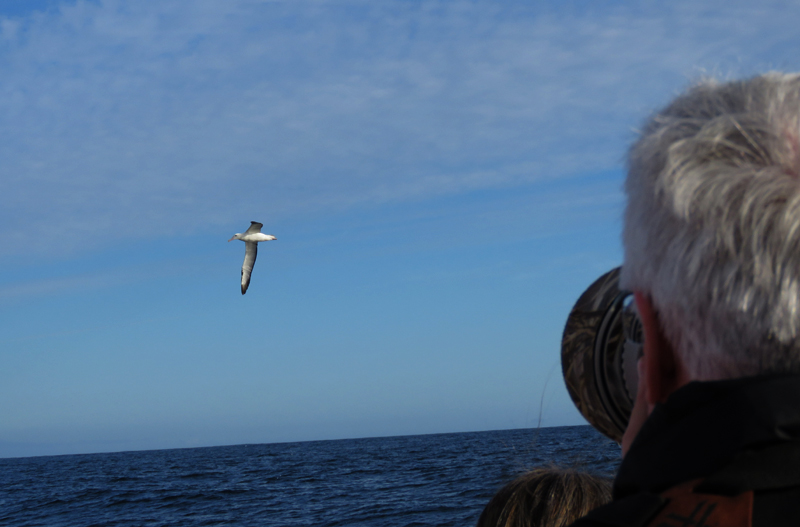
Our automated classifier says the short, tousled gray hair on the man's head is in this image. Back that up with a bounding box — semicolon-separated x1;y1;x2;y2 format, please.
621;73;800;380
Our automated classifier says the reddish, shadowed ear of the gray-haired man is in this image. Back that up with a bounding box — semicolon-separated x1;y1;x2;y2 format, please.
633;291;690;413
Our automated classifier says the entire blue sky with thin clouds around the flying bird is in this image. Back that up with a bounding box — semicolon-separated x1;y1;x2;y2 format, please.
0;0;800;457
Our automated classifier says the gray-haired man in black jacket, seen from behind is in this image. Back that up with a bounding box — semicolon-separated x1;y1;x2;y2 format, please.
575;73;800;527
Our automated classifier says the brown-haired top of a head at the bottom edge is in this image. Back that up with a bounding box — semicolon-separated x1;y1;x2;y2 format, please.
477;467;611;527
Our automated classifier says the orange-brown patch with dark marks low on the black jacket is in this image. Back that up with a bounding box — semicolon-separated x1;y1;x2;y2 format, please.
648;480;753;527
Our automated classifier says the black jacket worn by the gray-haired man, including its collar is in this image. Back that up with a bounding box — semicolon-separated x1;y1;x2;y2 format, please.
573;375;800;527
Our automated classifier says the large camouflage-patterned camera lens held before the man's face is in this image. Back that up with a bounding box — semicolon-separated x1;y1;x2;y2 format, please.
561;267;644;443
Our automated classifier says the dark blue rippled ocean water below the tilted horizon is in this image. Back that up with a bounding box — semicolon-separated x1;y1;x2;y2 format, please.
0;426;620;527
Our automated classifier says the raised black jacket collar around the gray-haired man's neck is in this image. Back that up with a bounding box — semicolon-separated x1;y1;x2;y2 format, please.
614;375;800;499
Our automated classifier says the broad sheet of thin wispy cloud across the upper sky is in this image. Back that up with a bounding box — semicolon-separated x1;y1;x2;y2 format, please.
0;0;800;255
